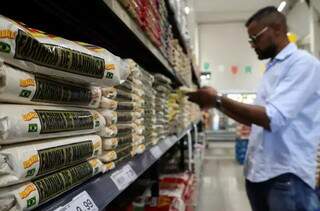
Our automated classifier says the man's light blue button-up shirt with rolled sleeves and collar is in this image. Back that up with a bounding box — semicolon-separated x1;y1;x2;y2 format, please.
245;44;320;187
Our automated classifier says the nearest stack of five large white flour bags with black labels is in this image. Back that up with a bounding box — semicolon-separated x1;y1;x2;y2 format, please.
0;16;130;211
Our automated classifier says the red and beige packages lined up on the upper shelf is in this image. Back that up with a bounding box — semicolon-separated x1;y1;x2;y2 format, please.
119;0;192;86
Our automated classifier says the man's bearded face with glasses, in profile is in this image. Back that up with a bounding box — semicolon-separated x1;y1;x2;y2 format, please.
247;21;277;60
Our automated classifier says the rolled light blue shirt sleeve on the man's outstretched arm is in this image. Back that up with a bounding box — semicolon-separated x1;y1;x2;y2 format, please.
266;56;320;132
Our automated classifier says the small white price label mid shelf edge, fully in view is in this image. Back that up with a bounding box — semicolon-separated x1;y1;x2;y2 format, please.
111;164;137;190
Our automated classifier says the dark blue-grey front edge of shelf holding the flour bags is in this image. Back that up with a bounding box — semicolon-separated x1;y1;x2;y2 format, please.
36;125;193;211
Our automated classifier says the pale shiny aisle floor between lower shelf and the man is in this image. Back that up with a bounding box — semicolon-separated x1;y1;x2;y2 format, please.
197;143;250;211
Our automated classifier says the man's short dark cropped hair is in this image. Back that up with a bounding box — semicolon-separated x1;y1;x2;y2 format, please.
246;6;288;32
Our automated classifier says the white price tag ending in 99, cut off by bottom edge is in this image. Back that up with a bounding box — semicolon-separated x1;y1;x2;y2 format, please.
55;191;99;211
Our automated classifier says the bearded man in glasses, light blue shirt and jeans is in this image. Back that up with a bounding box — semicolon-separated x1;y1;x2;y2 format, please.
189;7;320;211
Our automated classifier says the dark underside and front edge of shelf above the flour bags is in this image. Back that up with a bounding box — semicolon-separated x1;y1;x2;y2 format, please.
0;0;184;86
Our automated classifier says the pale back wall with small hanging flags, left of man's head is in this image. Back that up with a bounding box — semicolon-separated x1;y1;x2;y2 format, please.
199;22;265;92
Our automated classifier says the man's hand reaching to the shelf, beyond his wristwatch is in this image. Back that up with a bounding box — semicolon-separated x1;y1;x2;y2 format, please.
187;87;218;110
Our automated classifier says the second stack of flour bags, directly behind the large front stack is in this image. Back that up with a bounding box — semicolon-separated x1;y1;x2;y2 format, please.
99;60;145;172
